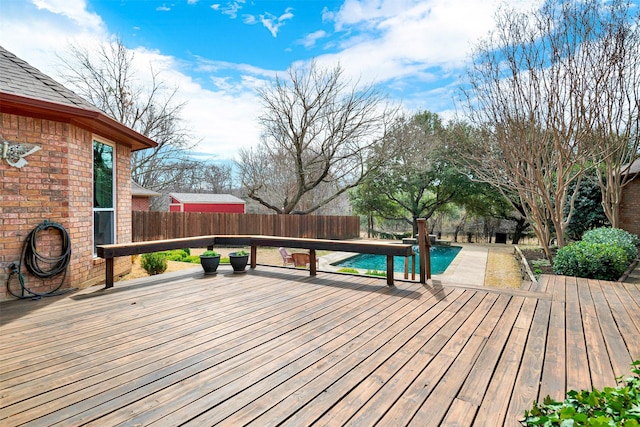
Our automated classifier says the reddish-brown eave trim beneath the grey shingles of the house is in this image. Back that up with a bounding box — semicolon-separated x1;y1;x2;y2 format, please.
0;92;158;151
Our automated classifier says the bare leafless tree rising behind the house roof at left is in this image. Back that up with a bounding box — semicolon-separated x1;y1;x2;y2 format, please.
60;40;230;196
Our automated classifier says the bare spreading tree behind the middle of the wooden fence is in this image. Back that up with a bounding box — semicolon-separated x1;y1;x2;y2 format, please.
238;62;395;214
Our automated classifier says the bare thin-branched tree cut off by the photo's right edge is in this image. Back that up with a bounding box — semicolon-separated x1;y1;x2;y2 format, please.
584;1;640;227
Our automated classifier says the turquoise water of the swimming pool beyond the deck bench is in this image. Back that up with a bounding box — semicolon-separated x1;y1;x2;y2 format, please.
333;246;462;274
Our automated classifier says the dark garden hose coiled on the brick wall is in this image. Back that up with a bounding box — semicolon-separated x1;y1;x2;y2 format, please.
7;220;71;298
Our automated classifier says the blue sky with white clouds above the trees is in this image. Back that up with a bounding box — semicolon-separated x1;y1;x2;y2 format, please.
0;0;534;160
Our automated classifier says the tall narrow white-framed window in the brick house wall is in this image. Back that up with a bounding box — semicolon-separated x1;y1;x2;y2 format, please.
93;141;116;253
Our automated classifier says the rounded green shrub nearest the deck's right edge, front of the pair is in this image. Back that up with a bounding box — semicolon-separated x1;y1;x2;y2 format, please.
553;240;629;280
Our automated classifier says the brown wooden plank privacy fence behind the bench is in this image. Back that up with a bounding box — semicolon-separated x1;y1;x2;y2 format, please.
131;211;360;242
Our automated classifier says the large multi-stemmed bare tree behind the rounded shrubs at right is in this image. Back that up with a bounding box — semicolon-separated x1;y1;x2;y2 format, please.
458;0;632;259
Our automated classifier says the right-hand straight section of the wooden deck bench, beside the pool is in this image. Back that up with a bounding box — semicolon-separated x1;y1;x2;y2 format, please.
250;236;415;286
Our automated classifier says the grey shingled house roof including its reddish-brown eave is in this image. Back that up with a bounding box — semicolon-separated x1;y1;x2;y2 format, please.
0;46;157;151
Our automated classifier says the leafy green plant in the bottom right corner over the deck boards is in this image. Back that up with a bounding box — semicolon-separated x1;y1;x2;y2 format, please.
521;360;640;427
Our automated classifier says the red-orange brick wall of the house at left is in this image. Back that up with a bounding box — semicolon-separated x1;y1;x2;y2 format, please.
0;113;131;300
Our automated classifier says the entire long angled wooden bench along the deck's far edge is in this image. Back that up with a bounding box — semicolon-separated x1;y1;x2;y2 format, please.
97;235;415;288
